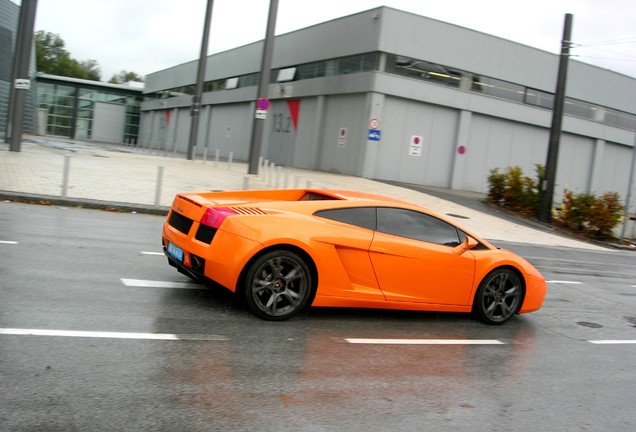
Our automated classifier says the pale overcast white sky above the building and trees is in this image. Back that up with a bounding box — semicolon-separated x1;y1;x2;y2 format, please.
23;0;636;81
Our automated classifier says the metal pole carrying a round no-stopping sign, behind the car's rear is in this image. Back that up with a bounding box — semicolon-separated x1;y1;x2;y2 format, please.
248;0;278;174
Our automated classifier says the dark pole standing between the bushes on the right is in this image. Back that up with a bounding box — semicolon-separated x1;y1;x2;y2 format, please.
539;14;572;223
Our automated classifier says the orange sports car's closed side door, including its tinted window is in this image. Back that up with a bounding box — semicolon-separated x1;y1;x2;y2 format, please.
369;207;475;305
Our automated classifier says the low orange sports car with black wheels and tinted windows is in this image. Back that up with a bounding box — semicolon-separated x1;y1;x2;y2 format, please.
163;189;546;324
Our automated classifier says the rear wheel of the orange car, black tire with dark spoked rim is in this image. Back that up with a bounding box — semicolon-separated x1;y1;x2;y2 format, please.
244;250;314;321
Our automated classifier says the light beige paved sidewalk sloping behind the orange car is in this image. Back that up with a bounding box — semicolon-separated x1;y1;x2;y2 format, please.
0;137;604;250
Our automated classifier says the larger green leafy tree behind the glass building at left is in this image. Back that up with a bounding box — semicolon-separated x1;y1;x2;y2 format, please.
35;30;101;81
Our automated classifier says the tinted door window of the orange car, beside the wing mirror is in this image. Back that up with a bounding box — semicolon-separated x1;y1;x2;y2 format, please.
377;207;465;247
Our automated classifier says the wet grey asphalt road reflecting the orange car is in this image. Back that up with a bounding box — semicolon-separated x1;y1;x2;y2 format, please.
0;203;636;431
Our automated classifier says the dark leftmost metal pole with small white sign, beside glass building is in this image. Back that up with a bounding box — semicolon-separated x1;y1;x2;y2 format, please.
5;0;38;152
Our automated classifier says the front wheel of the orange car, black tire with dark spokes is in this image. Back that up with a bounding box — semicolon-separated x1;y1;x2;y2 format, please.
473;268;524;325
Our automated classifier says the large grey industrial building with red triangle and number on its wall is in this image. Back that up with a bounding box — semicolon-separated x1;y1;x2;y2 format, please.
139;7;636;201
